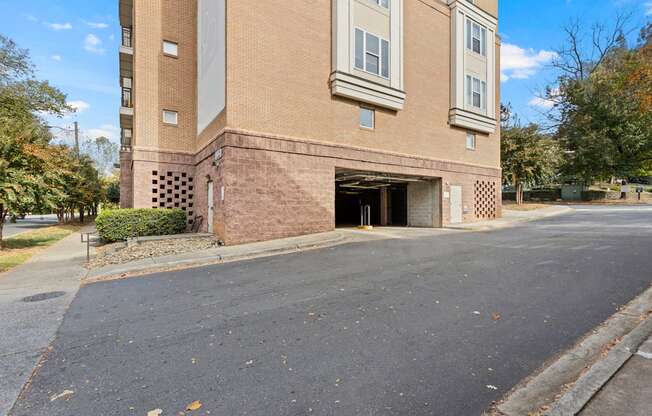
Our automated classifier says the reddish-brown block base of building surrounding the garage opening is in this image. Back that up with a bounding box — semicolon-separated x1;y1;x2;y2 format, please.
121;129;502;244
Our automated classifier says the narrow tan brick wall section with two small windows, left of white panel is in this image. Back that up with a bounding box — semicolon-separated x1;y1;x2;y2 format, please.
133;0;197;153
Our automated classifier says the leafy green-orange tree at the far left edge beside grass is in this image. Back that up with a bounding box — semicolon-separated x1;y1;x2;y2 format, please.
0;35;76;242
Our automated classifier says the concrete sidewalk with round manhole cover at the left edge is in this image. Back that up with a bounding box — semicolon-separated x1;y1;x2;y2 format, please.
0;228;93;415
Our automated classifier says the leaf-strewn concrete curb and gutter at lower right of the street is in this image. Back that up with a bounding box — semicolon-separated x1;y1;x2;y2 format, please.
486;288;652;416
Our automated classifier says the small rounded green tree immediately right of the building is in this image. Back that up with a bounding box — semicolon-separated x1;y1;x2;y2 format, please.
500;107;560;205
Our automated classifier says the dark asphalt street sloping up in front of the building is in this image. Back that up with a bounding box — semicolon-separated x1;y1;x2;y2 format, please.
8;206;652;416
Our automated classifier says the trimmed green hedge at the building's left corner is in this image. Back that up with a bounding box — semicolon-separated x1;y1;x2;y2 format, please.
95;209;186;242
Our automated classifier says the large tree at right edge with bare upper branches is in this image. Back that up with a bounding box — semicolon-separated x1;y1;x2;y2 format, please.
545;15;652;184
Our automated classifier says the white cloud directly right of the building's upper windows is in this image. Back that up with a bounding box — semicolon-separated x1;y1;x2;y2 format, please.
500;43;557;82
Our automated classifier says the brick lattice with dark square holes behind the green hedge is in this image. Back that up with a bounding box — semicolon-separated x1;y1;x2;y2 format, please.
152;170;195;225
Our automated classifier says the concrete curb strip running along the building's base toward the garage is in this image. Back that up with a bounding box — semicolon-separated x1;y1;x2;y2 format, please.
82;235;349;285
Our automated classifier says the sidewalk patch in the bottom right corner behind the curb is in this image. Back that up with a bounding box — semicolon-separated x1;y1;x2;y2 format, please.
579;336;652;416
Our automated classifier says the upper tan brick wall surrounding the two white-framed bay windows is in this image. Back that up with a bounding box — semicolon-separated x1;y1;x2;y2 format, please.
226;0;500;171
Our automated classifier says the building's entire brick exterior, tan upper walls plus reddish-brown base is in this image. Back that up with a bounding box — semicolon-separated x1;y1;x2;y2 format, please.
131;0;501;244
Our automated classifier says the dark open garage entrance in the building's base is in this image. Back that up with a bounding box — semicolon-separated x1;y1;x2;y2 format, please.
335;169;441;227
